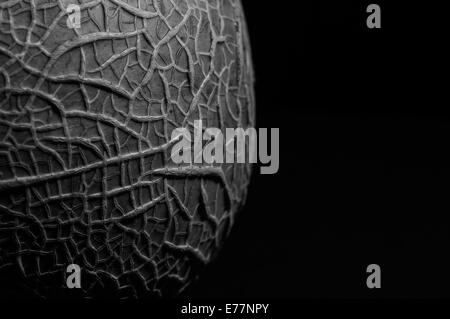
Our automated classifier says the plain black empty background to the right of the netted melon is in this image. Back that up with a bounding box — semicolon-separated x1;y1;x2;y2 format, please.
189;0;450;298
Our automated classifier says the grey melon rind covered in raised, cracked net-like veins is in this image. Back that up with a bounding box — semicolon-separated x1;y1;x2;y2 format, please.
0;0;255;298
